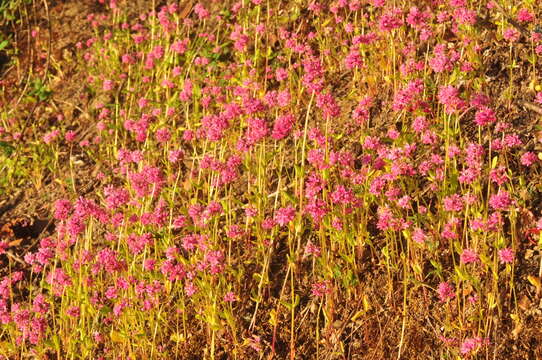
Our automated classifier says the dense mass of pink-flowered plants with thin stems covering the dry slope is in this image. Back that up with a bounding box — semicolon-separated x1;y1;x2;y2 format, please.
0;0;542;359
